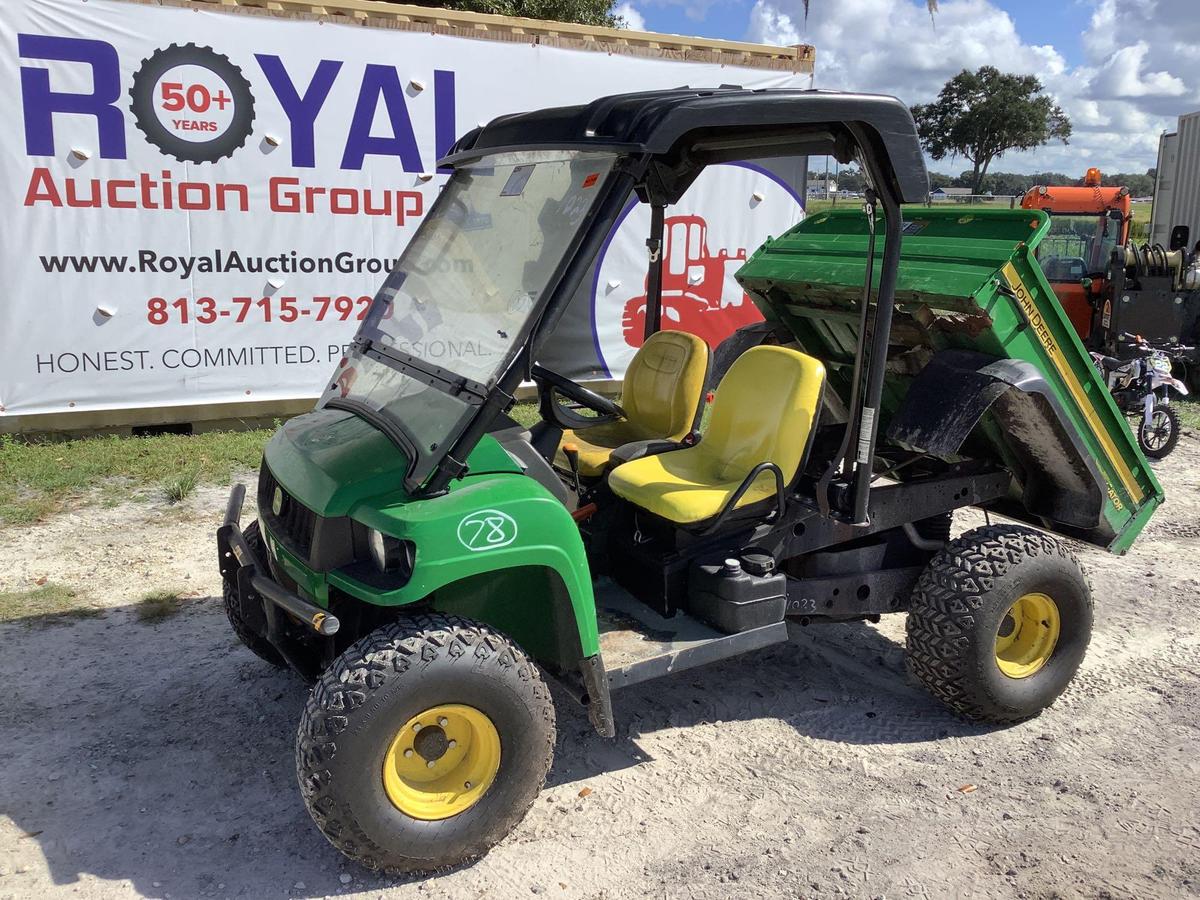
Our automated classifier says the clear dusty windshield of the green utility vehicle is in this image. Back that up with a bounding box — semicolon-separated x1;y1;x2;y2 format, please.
320;150;617;486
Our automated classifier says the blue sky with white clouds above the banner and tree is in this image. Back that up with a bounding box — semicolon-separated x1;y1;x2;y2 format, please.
618;0;1200;174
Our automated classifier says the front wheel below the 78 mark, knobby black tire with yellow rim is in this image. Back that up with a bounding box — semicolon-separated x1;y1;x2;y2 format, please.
296;614;554;872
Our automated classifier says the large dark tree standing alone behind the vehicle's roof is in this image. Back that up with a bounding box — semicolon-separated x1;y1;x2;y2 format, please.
912;66;1070;193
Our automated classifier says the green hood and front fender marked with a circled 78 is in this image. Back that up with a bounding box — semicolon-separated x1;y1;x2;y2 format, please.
265;409;599;655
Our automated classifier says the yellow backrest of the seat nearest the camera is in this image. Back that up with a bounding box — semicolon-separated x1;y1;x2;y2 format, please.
697;347;826;484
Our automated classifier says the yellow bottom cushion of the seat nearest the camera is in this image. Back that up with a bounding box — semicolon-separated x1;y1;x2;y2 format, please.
608;444;775;524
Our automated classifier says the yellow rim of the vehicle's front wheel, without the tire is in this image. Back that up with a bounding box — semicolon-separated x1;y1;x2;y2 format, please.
383;703;500;821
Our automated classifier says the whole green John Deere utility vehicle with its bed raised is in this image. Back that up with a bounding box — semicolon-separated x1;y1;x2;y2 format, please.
217;89;1163;870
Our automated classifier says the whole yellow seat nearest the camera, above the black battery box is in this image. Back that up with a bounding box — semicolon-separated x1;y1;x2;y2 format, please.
608;347;824;524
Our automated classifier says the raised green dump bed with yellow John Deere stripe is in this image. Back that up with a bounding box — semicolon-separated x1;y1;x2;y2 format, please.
737;209;1163;552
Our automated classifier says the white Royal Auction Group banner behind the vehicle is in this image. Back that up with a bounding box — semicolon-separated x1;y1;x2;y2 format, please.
0;0;809;416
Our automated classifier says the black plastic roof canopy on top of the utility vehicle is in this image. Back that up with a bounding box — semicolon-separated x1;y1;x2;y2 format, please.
444;88;929;203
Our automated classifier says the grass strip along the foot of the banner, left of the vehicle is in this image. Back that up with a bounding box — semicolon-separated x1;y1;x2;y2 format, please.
0;428;274;523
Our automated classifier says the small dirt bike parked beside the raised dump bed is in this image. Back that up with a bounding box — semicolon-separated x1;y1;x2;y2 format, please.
1092;335;1188;460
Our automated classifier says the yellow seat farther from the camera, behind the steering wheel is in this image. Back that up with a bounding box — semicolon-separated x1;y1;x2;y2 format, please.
554;331;710;478
